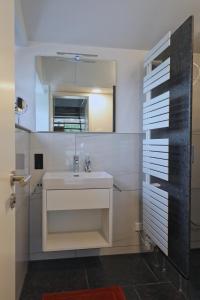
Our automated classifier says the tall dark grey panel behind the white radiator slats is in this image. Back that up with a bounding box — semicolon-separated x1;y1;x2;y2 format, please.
151;17;193;278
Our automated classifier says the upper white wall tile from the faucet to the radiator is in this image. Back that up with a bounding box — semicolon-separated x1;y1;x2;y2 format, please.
76;134;141;190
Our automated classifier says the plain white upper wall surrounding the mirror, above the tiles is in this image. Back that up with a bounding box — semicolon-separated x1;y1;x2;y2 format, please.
16;43;146;133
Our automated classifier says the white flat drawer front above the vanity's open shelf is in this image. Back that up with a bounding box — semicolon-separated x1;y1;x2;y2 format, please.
47;189;110;211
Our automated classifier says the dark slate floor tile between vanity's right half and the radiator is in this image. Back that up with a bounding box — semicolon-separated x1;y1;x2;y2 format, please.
85;255;157;288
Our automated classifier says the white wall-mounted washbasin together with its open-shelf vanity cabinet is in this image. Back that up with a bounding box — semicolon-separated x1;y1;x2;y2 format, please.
42;172;113;252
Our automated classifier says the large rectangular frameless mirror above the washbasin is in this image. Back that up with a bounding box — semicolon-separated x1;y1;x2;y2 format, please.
35;55;116;133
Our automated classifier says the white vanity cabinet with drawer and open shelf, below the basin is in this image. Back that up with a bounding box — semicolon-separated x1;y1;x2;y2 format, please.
42;172;113;251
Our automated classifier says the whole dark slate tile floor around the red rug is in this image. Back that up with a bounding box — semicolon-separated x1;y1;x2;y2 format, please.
20;254;185;300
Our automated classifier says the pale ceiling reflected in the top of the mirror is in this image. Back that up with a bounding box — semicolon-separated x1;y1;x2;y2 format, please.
35;56;116;94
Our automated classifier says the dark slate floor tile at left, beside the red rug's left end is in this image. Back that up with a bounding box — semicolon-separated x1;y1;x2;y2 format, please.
20;260;88;300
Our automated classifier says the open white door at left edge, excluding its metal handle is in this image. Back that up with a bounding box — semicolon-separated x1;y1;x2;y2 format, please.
0;0;15;300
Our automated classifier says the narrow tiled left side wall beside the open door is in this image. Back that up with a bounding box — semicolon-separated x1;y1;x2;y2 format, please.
15;129;30;299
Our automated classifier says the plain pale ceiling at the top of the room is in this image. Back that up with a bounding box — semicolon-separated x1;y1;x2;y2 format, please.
17;0;200;49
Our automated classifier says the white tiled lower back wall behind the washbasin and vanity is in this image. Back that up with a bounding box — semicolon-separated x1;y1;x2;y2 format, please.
30;133;142;259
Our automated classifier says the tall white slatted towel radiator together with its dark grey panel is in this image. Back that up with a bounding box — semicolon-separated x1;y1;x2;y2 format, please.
143;17;194;278
